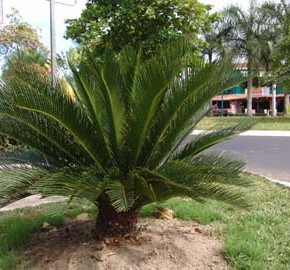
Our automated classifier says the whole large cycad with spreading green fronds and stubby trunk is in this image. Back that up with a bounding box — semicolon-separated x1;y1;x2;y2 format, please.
0;43;246;236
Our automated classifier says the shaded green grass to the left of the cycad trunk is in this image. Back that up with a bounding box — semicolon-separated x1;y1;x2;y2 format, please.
0;200;96;270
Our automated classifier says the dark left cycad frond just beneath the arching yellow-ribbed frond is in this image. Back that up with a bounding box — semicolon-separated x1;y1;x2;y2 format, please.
0;113;90;166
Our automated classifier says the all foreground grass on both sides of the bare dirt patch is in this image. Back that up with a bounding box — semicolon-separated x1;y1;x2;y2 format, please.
0;175;290;270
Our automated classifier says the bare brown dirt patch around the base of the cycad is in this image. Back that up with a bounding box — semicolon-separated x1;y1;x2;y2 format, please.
23;218;229;270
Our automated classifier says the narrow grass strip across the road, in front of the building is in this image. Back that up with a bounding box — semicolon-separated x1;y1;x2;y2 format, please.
196;116;290;130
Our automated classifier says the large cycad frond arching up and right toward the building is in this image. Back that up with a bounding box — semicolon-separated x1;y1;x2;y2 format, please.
144;56;244;168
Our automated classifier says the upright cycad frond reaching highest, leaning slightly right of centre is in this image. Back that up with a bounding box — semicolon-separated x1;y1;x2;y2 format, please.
123;41;184;169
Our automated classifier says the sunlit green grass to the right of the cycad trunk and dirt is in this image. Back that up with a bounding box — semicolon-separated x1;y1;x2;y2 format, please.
141;175;290;270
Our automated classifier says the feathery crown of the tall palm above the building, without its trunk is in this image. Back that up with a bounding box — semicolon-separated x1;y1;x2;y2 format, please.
222;2;274;75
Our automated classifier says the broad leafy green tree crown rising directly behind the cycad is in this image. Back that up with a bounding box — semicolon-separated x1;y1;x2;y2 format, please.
65;0;215;55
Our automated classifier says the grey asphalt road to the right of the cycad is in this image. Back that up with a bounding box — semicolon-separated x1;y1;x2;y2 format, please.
212;136;290;183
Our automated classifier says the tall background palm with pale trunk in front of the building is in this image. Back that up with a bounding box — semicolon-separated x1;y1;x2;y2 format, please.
223;0;269;116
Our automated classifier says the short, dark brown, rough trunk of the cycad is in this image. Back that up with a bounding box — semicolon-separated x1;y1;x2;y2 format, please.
96;198;138;239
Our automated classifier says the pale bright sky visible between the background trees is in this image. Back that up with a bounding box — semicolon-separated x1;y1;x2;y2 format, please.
0;0;270;53
